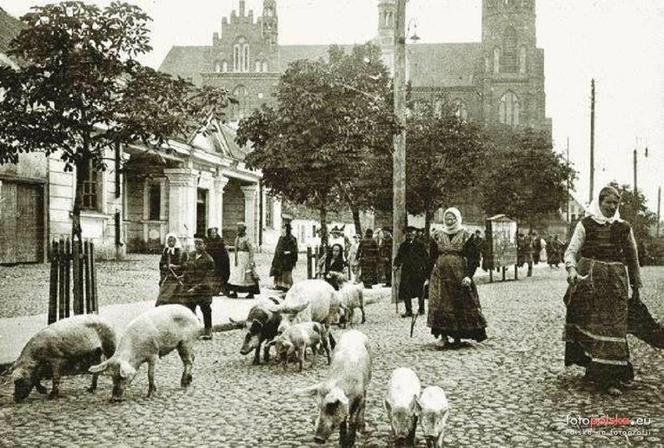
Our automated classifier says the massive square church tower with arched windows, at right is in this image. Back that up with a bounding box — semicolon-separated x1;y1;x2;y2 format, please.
482;0;548;129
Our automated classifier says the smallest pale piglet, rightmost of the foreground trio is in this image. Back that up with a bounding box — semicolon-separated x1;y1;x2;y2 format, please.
417;386;450;448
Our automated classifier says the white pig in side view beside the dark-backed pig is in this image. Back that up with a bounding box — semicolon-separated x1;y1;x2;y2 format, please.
90;305;203;401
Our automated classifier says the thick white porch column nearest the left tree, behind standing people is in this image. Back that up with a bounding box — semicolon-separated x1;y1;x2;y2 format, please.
164;168;198;247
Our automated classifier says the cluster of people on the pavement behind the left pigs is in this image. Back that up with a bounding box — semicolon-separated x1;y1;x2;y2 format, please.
156;223;260;340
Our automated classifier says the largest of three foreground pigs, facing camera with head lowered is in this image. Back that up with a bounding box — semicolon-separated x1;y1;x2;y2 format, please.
299;330;371;447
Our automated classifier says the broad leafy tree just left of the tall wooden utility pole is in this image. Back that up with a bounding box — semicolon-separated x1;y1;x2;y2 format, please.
237;44;397;245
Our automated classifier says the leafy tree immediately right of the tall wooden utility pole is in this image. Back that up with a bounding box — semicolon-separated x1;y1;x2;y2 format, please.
406;106;486;235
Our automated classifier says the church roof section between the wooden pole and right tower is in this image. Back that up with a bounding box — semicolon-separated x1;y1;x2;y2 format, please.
407;42;482;87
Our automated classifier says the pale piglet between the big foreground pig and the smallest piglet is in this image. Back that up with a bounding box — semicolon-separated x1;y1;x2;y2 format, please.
384;367;422;446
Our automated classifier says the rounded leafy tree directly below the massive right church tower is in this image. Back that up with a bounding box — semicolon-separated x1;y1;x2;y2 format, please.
480;127;576;225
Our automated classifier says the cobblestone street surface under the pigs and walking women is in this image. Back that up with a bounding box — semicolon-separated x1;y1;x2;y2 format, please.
0;268;664;448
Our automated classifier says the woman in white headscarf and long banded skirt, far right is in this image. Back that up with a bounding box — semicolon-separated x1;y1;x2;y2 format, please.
564;186;664;395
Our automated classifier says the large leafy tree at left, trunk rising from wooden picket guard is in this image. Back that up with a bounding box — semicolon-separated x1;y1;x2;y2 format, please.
0;1;233;241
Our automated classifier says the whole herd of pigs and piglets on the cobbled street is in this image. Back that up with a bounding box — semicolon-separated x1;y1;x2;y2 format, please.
5;279;449;448
